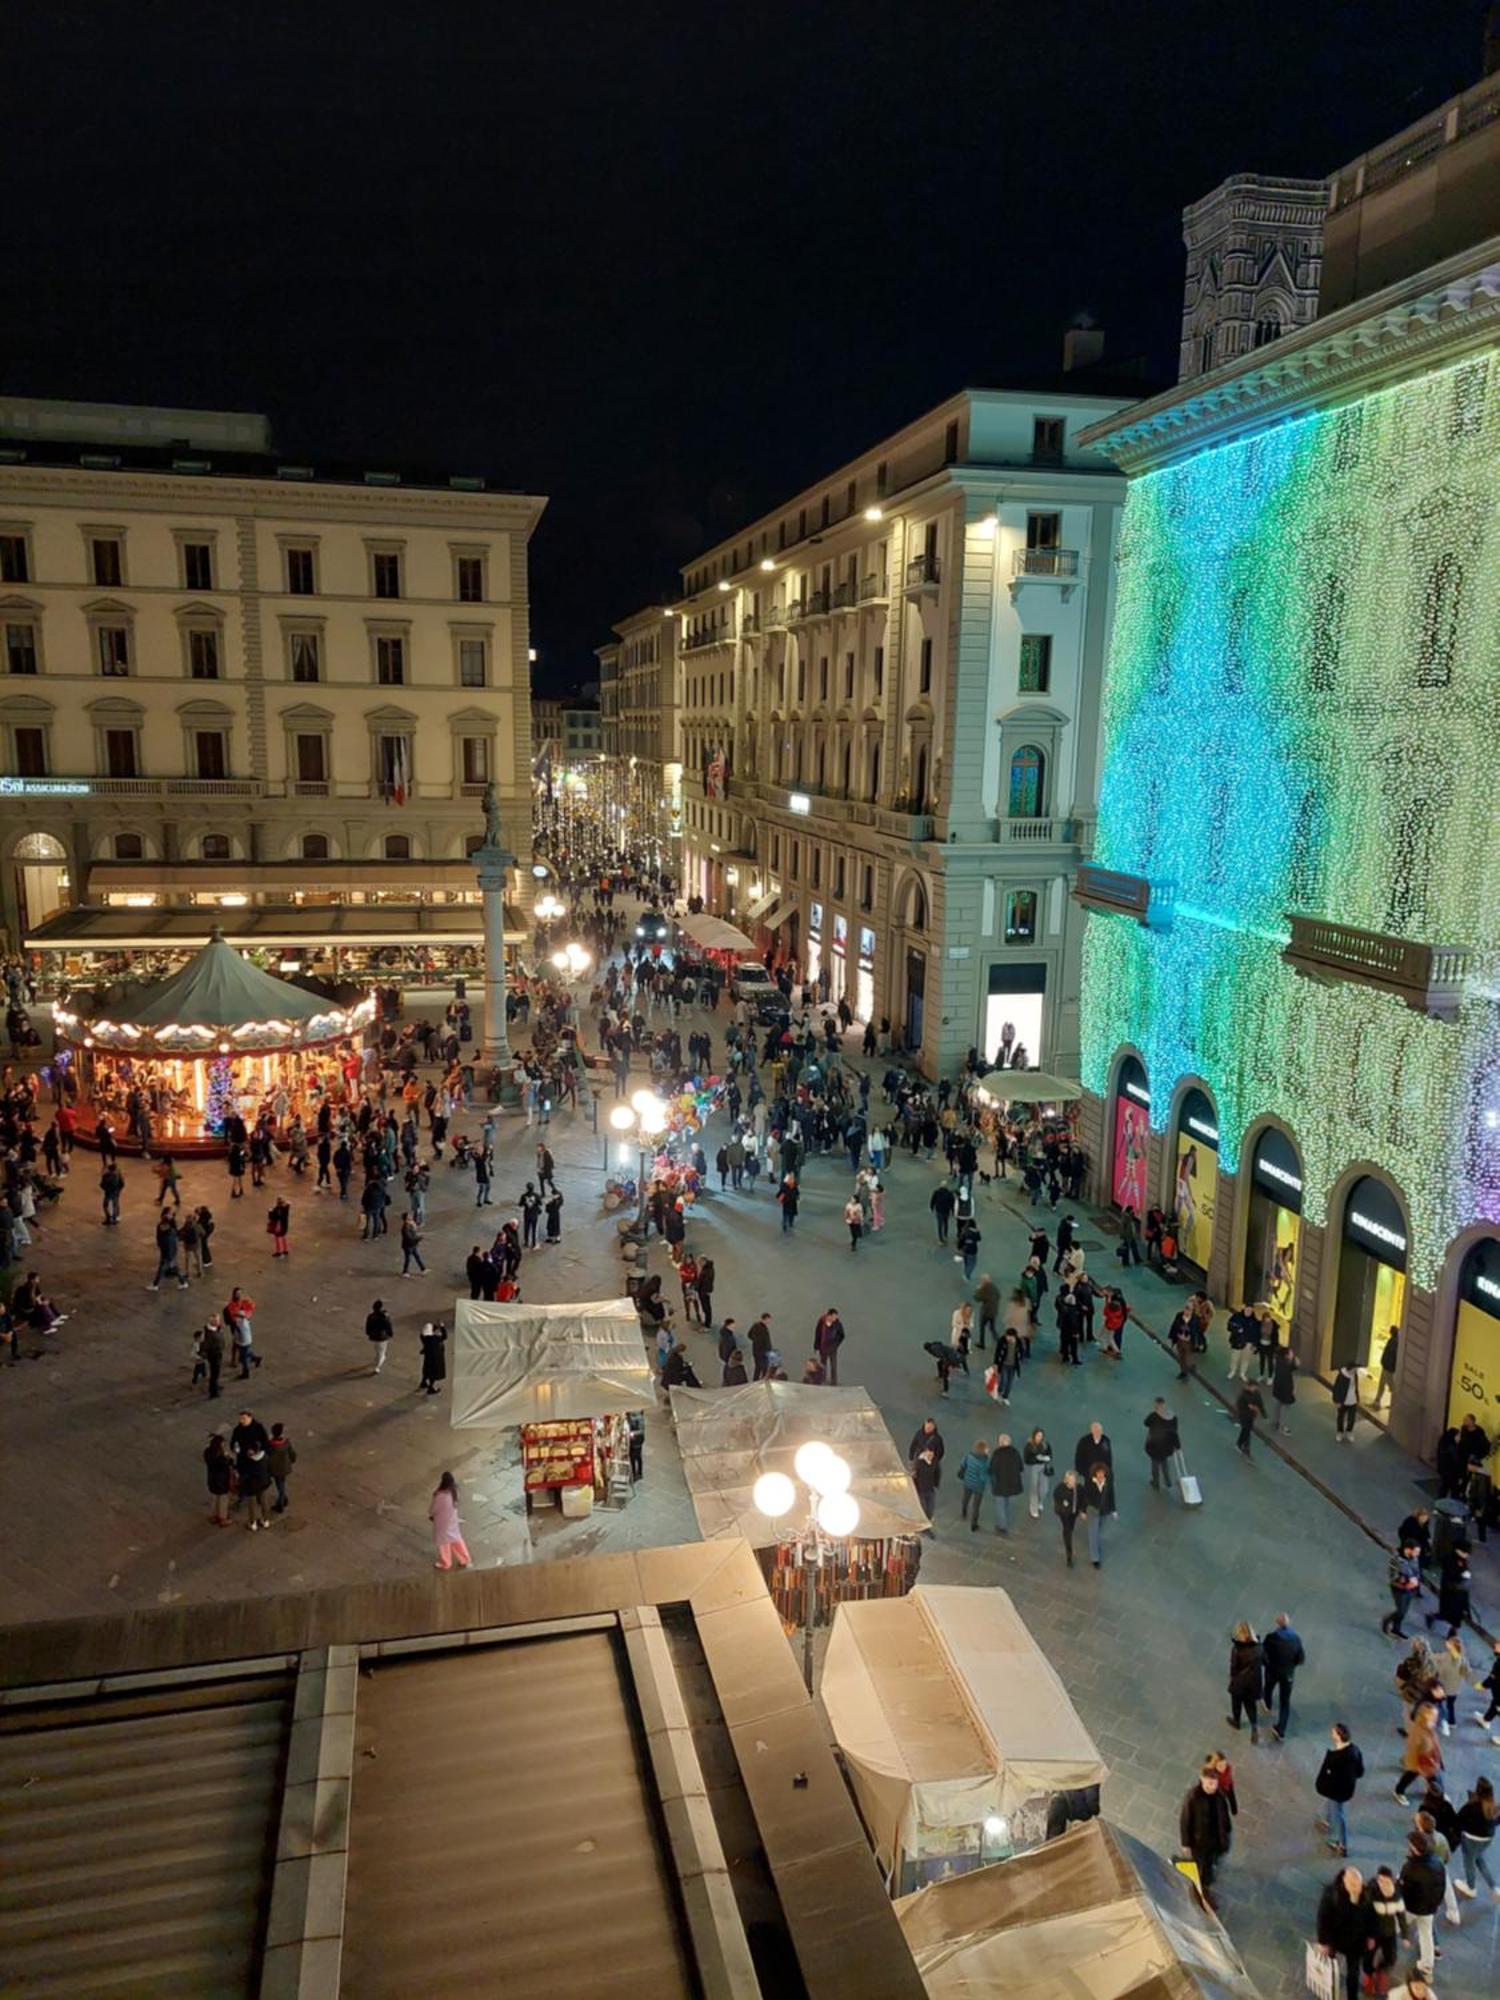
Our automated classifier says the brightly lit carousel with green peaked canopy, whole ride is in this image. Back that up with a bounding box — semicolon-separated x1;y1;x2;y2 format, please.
54;932;376;1154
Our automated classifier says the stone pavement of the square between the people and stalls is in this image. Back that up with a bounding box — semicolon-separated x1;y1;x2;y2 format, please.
0;976;1500;2000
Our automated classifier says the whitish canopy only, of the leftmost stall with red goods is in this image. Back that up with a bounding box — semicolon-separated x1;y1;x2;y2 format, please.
452;1298;656;1430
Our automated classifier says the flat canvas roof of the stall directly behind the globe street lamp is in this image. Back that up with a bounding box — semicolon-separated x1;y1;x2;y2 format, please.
672;1382;928;1548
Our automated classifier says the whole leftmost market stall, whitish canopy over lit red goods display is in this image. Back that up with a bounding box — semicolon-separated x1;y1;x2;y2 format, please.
452;1298;656;1514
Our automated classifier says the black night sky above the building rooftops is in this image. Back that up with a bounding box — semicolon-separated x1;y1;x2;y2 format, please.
0;0;1484;688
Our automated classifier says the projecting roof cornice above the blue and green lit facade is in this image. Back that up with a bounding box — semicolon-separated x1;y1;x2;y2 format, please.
1078;238;1500;476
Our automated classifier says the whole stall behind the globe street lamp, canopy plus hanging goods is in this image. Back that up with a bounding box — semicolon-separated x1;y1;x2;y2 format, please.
672;1382;928;1628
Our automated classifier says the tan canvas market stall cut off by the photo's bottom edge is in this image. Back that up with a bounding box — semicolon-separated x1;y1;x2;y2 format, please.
896;1820;1258;2000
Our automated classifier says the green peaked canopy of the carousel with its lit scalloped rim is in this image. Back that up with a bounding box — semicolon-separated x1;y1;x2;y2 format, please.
56;932;374;1056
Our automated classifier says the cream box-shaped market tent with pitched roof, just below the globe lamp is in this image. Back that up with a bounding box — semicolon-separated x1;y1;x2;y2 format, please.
822;1584;1108;1894
